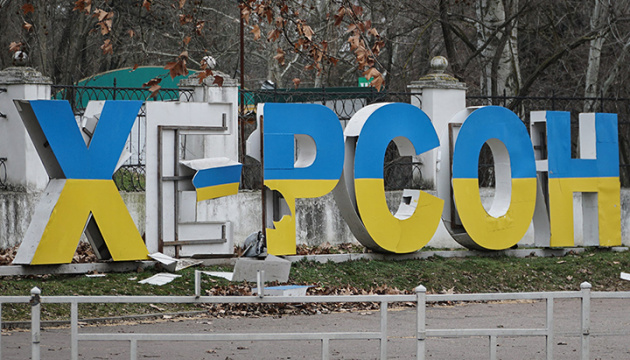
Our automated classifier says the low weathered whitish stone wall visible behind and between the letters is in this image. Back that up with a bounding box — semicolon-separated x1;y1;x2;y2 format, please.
0;189;630;249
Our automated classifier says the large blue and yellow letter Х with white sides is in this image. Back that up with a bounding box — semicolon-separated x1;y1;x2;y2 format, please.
14;100;148;265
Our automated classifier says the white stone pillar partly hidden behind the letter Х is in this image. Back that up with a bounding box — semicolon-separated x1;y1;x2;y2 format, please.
0;67;52;192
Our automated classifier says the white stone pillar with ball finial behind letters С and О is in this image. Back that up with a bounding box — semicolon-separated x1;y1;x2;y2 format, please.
407;56;466;188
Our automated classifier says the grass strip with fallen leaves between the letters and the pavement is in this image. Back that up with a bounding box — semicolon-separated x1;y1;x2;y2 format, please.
0;250;630;321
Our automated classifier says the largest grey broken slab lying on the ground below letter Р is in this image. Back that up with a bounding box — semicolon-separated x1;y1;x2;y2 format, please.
232;255;291;282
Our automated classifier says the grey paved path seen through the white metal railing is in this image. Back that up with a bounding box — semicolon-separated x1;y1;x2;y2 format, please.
2;300;630;360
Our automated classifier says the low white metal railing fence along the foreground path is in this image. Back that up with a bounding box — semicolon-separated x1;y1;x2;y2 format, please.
0;282;630;360
